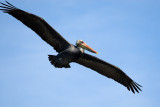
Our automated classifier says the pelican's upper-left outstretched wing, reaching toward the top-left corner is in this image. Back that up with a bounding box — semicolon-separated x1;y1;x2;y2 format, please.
0;1;70;52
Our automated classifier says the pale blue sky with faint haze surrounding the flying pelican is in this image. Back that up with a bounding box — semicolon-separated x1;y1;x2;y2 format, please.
0;0;160;107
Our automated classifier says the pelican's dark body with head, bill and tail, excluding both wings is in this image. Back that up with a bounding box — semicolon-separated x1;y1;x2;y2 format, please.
49;40;98;68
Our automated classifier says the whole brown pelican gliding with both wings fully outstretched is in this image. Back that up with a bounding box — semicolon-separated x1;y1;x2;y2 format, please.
0;1;141;93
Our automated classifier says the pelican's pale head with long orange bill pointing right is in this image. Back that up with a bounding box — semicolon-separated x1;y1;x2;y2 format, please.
76;40;98;54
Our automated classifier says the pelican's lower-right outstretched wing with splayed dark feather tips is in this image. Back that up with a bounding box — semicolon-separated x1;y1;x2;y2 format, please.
76;53;141;93
